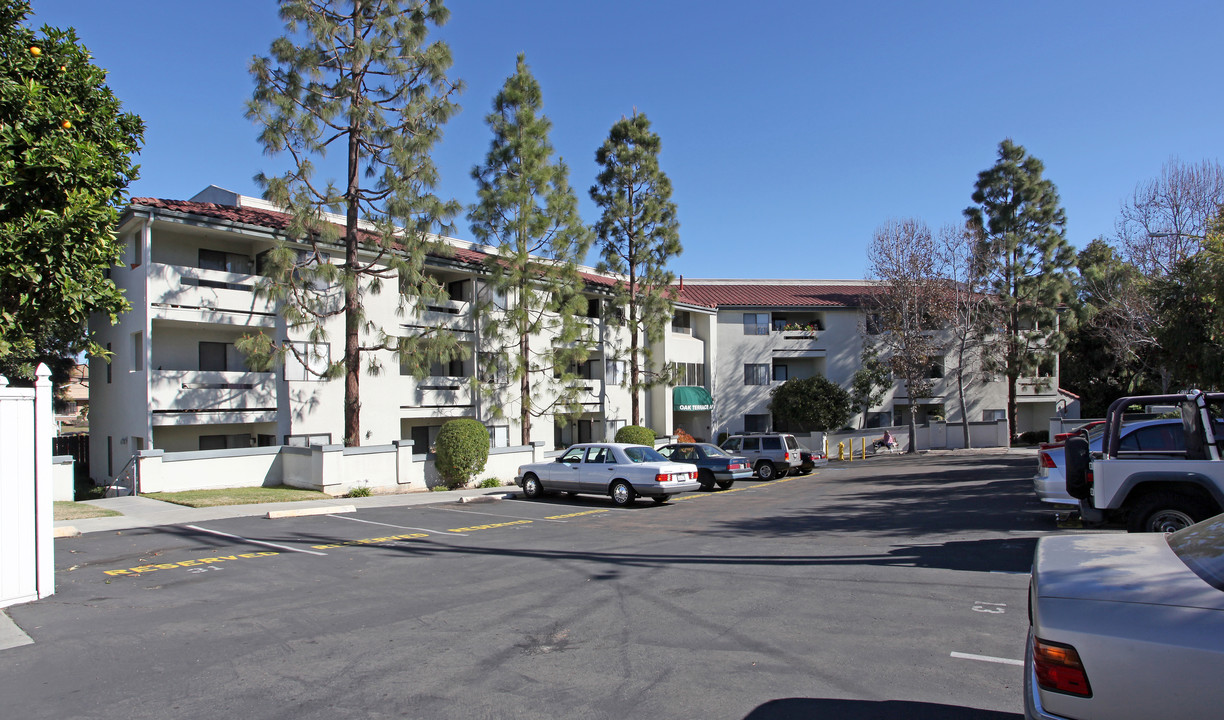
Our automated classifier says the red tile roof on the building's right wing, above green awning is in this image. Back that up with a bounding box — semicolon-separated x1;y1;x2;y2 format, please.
681;280;879;307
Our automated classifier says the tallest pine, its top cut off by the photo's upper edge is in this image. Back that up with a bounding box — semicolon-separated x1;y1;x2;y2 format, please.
240;0;463;446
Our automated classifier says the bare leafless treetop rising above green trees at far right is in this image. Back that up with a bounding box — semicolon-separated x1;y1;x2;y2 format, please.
1116;158;1224;277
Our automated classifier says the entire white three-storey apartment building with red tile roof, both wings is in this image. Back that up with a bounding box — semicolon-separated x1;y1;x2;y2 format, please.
89;187;1061;480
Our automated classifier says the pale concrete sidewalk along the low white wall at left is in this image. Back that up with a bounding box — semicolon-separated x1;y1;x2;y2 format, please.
55;486;518;536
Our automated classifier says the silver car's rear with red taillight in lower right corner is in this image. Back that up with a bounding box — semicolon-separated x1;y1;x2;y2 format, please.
1024;514;1224;720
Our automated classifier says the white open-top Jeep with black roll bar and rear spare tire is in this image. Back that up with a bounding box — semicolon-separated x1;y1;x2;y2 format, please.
1066;391;1224;533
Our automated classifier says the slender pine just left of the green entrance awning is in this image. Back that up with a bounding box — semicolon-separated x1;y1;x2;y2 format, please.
591;113;683;425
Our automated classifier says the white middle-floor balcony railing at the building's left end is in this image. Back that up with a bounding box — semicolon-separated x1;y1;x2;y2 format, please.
149;370;277;413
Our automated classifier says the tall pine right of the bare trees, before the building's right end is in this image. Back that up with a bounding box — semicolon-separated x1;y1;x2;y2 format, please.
965;140;1075;433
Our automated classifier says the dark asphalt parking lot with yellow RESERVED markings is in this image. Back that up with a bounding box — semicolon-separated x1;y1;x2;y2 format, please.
0;454;1065;720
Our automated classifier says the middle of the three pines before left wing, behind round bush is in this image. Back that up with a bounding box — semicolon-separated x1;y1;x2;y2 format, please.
468;55;591;444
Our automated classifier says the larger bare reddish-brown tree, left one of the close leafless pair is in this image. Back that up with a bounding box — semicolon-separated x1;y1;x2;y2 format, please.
867;219;949;452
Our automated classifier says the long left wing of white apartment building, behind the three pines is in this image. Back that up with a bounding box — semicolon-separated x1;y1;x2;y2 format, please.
91;187;680;480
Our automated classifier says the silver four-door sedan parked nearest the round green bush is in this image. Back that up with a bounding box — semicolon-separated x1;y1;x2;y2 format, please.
514;442;701;506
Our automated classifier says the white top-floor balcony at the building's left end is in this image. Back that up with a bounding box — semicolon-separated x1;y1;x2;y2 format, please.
148;262;277;327
